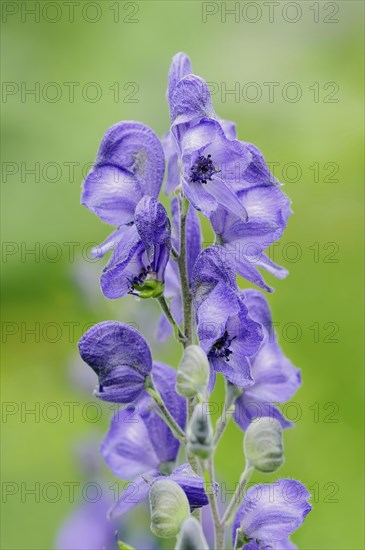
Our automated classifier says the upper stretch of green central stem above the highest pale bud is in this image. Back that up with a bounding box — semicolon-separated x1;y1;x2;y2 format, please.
177;197;193;347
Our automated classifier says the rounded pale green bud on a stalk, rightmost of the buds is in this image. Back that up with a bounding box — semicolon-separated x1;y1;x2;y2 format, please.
243;417;284;473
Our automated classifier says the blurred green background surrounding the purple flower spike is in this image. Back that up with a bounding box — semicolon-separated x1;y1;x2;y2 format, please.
1;1;364;550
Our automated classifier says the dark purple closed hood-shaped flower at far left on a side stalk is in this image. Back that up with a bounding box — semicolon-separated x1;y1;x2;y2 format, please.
79;321;152;403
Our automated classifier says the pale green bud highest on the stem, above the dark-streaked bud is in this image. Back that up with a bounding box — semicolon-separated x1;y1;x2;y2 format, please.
176;345;210;397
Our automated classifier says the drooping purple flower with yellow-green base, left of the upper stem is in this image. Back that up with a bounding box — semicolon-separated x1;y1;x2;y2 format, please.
100;196;171;298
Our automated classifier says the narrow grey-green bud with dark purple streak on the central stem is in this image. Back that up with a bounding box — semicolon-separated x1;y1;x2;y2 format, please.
186;403;213;459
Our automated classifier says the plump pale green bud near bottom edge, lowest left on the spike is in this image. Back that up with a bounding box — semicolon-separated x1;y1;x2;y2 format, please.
149;479;190;539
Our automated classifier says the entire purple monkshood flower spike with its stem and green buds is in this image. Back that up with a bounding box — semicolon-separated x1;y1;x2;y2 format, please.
73;52;311;550
